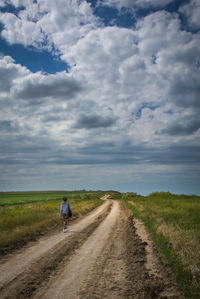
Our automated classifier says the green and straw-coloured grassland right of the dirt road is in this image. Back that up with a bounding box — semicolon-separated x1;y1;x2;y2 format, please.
122;192;200;298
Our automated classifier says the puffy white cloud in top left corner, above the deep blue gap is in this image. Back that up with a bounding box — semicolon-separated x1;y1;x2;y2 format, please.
0;0;99;52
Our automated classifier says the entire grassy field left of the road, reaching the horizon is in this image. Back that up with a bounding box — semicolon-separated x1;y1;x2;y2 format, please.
0;191;104;253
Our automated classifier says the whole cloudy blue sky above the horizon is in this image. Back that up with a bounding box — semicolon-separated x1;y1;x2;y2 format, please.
0;0;200;195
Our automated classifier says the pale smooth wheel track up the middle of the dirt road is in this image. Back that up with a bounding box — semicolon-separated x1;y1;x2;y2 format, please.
35;202;119;299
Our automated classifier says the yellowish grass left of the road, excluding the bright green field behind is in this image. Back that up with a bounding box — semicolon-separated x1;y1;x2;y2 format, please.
0;193;102;253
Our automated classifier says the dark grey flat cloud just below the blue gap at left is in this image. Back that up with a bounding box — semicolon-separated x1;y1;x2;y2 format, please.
18;75;82;100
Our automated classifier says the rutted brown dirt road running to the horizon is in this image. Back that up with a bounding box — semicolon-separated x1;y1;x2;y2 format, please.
0;200;183;299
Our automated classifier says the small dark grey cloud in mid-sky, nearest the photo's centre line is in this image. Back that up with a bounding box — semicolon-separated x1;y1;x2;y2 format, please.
73;114;116;129
